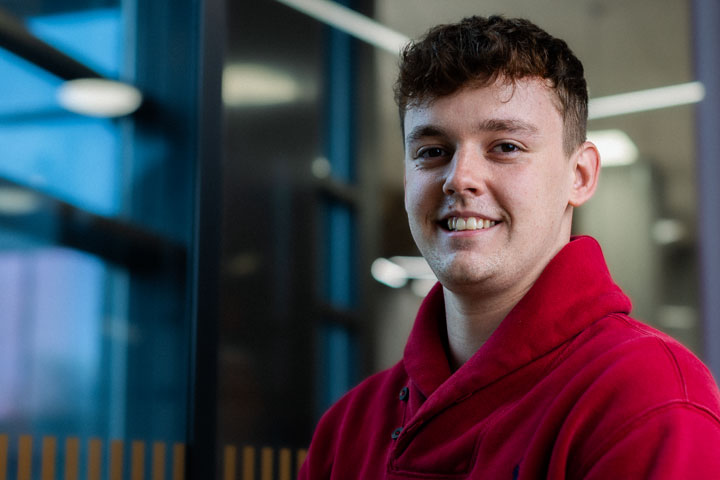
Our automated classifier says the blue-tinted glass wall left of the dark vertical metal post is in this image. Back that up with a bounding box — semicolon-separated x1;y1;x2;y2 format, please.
0;0;207;479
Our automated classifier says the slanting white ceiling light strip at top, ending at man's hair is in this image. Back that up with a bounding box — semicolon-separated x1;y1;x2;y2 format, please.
277;0;410;55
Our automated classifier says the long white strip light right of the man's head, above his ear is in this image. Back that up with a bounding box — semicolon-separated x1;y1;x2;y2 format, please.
588;82;705;120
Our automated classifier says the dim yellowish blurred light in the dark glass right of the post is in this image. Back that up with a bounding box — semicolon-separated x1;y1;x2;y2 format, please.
222;64;302;107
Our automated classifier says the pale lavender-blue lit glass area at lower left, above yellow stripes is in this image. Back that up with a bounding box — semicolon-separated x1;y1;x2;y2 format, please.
0;247;109;434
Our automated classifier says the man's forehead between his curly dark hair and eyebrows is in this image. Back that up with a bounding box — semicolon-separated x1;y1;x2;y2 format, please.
403;78;563;143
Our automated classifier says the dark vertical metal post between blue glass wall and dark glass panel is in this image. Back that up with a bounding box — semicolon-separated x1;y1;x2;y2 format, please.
187;0;226;480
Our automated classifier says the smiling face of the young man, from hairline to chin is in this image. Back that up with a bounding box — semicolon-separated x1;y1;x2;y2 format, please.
404;79;575;292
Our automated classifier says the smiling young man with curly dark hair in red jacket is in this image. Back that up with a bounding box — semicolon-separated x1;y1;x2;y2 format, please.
300;17;720;480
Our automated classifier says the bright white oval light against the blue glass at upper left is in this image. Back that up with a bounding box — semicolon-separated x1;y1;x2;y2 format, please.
57;78;142;118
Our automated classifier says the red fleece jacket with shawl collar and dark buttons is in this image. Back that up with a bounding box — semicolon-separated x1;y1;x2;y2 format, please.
300;237;720;480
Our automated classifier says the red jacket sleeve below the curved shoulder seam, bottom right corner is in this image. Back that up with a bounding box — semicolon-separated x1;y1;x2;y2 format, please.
578;402;720;480
